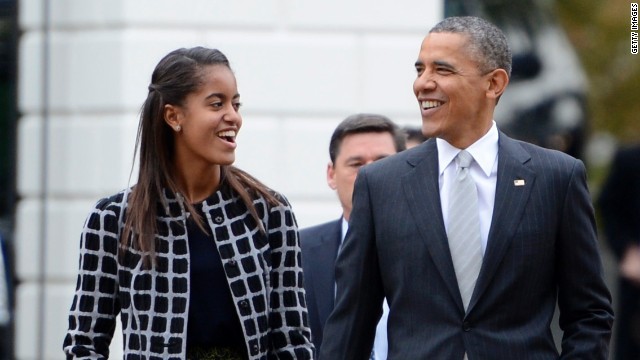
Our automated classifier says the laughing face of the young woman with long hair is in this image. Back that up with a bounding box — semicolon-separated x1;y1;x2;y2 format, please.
165;65;242;168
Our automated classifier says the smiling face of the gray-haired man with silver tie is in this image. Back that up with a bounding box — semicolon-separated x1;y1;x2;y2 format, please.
413;33;495;148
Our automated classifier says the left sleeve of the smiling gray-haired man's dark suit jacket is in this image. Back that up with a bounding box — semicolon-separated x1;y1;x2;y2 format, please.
318;166;384;360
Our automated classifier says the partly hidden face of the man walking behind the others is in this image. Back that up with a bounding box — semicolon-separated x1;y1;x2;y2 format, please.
327;132;396;220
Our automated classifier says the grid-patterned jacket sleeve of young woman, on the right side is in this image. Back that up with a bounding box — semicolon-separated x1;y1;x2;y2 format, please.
267;197;314;360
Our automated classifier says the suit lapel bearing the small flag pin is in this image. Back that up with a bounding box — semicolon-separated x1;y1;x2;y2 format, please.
469;132;535;310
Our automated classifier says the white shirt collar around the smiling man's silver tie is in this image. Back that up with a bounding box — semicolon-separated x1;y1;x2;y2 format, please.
436;121;499;176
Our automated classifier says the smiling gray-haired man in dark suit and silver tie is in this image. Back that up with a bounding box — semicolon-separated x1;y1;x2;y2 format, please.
320;17;613;360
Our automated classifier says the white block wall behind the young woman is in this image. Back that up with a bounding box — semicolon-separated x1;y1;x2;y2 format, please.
15;0;443;359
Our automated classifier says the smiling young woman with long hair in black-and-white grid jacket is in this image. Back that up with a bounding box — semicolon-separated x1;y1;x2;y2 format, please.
64;47;313;359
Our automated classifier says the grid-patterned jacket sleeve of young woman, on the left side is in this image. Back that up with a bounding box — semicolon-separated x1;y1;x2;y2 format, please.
63;199;120;359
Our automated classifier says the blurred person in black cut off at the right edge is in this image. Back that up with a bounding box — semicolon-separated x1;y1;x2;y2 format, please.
598;145;640;360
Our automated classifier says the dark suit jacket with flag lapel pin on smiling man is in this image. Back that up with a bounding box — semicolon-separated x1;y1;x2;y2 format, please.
320;133;613;360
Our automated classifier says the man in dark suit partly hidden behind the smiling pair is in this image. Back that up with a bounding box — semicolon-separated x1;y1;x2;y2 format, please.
300;114;405;360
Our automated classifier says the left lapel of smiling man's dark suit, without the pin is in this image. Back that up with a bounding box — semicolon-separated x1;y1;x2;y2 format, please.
401;139;462;307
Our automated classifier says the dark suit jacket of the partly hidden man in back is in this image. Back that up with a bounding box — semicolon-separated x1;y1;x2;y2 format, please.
300;218;342;351
